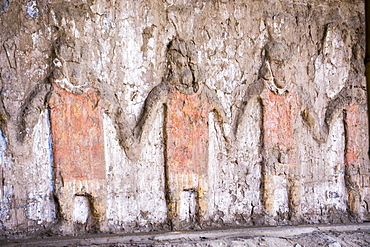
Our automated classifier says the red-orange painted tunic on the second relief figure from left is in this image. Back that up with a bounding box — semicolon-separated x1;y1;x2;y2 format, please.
166;90;210;174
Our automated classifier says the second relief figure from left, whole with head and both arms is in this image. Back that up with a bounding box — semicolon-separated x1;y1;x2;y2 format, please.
134;39;225;228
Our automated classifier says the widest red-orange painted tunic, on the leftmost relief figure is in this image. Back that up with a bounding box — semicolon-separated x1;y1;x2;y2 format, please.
49;84;105;180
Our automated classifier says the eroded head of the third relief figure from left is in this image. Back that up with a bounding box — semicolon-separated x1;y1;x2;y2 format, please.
260;41;293;94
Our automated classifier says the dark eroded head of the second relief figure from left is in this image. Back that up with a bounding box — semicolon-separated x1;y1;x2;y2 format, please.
166;39;199;94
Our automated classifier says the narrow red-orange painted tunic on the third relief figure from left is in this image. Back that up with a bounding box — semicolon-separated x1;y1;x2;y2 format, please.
261;89;300;164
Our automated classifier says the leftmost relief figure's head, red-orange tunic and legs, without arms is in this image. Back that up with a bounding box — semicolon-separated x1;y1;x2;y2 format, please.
48;39;106;231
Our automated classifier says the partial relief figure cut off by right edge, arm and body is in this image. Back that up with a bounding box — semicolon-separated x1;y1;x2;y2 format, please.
304;74;370;222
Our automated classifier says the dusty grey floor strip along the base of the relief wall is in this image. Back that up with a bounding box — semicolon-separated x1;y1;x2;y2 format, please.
0;223;370;247
